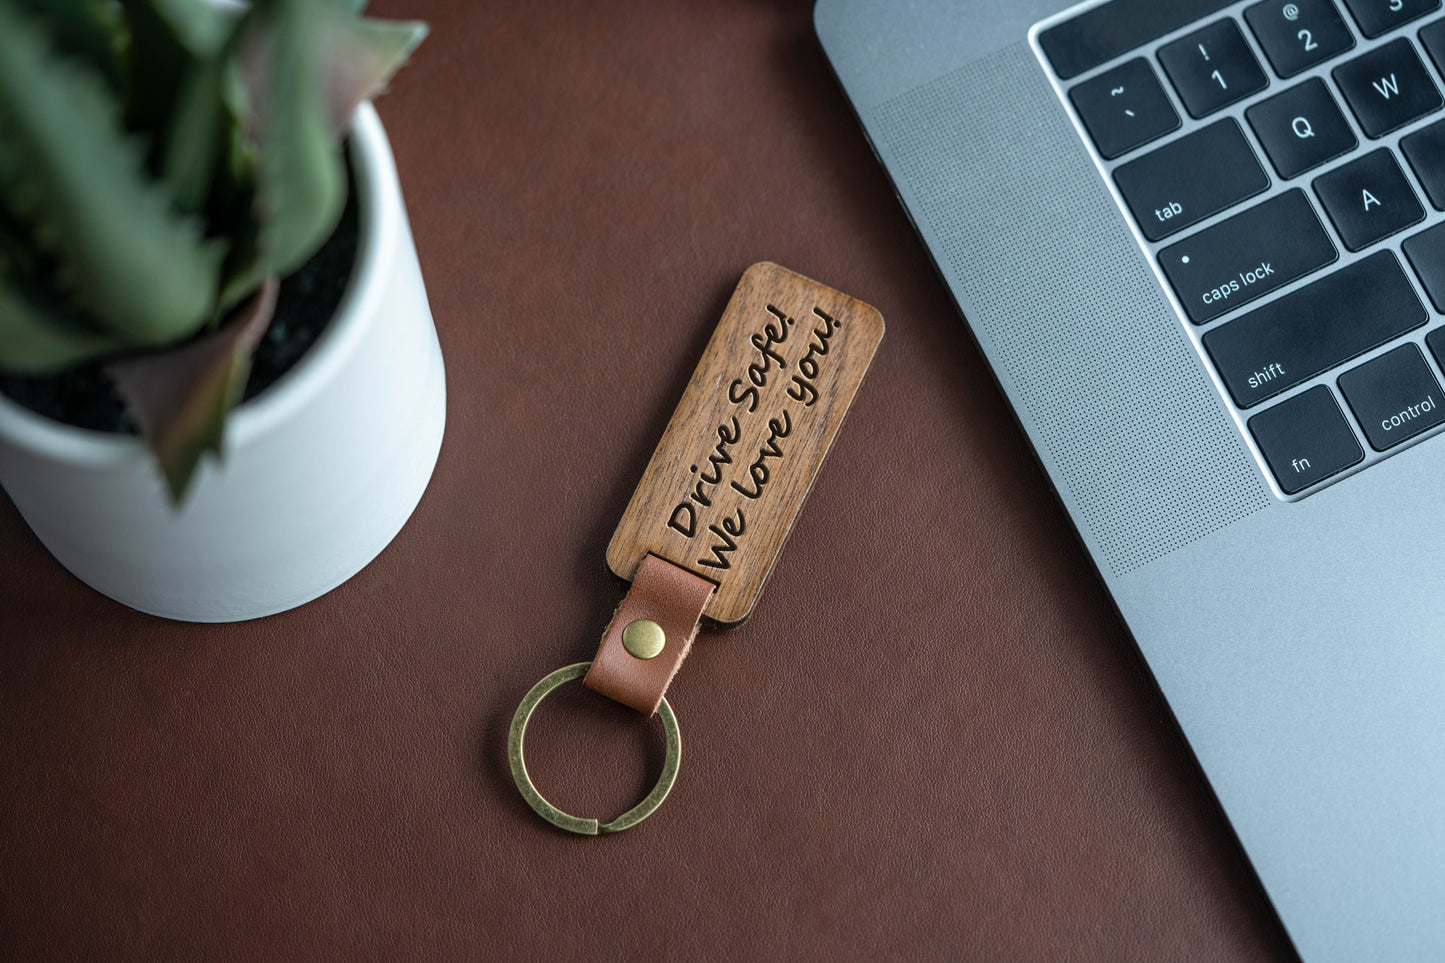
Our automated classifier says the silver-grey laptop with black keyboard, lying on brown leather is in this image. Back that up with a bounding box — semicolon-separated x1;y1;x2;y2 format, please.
815;0;1445;963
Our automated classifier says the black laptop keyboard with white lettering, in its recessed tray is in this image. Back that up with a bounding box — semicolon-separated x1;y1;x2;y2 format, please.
1035;0;1445;497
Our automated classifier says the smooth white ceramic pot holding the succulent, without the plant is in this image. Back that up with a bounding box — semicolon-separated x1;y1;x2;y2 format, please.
0;104;447;622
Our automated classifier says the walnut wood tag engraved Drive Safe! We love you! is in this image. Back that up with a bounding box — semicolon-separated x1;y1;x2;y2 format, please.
607;262;883;623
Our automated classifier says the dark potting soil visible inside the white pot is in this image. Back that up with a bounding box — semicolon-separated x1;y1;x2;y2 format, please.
0;180;361;435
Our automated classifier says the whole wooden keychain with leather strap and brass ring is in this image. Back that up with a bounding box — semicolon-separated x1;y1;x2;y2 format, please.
507;262;883;836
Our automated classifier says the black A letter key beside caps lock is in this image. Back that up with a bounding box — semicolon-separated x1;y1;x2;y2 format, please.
1315;147;1425;250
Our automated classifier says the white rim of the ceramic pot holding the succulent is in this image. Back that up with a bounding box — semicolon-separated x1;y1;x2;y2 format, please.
0;103;403;466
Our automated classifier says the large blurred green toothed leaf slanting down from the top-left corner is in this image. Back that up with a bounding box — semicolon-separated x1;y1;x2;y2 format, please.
0;4;225;346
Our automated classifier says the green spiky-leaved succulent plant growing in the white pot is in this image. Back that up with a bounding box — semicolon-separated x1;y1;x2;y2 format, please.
0;0;426;503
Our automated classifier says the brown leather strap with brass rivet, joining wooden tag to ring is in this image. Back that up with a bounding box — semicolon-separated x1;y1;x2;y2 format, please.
582;554;715;716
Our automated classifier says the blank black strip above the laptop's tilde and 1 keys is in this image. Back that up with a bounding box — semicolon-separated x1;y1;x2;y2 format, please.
1039;0;1234;80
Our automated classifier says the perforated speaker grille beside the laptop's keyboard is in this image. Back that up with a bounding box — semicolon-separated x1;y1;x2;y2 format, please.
868;43;1274;575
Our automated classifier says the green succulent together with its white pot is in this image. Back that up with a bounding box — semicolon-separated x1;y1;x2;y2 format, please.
0;0;445;622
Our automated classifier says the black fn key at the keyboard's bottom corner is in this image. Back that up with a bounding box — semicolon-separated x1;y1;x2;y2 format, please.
1250;385;1364;495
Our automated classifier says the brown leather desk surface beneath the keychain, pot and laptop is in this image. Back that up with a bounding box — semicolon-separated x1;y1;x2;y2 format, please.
0;0;1289;960
